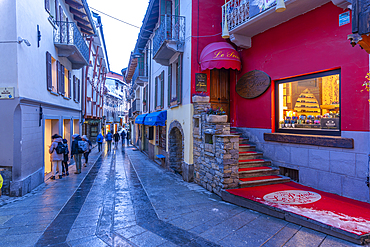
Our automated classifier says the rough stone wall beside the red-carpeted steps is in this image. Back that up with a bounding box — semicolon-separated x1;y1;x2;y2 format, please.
193;103;239;195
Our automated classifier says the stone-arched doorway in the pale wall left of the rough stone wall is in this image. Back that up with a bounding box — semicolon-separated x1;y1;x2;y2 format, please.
168;121;184;174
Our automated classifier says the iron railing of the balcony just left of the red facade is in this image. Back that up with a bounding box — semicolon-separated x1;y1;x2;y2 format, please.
153;15;185;55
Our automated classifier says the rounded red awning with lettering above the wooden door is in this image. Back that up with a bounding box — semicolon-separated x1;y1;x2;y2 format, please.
200;42;241;70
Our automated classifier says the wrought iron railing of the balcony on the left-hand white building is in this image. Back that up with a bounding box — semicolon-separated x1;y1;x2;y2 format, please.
54;21;89;62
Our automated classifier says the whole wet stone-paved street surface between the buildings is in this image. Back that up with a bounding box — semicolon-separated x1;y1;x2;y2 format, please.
0;146;366;247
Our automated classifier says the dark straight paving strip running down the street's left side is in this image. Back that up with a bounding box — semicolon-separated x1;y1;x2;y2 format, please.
35;151;105;246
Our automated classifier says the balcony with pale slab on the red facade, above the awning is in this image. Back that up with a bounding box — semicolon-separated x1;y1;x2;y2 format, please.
222;0;330;49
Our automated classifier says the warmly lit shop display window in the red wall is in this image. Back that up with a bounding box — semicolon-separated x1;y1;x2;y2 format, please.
276;70;340;135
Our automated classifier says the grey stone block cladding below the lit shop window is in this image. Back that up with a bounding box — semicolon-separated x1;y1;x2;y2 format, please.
237;128;370;202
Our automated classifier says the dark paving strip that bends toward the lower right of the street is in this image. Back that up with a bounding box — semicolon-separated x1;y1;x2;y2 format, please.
123;148;220;246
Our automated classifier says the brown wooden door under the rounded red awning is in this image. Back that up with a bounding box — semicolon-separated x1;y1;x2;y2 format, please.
210;69;230;119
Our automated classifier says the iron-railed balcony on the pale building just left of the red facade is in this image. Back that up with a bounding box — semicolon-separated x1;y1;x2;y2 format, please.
153;15;185;66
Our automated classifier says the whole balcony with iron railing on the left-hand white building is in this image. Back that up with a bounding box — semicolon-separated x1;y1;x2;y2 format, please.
54;21;89;69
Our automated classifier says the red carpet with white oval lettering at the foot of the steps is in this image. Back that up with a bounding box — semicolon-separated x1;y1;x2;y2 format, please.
227;182;370;236
